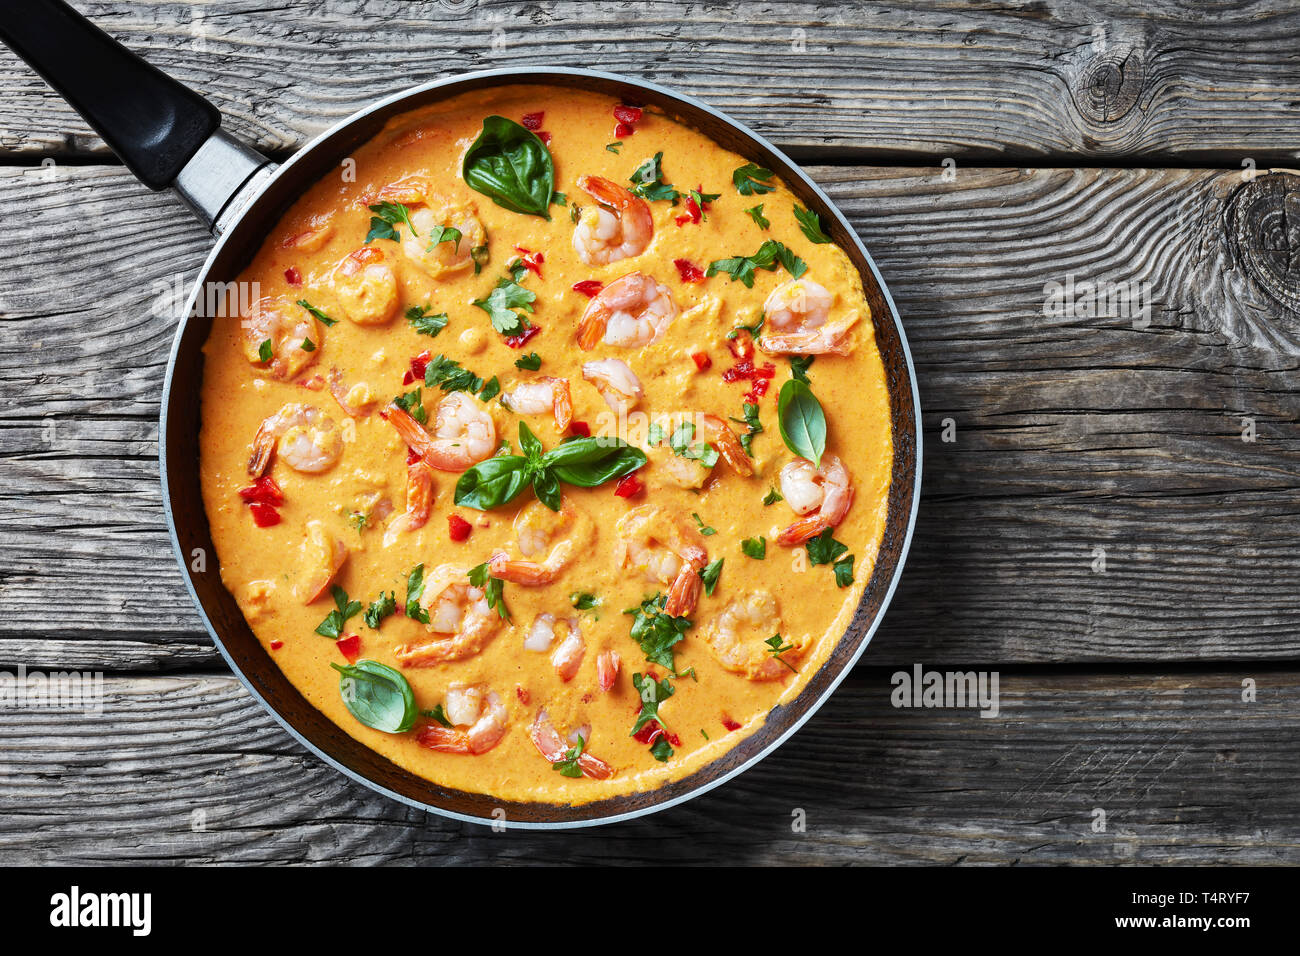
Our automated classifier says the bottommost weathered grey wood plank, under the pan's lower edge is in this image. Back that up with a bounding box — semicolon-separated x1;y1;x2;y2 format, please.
0;670;1300;865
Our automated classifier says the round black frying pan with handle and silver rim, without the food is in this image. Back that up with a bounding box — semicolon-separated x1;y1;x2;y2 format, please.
0;0;922;829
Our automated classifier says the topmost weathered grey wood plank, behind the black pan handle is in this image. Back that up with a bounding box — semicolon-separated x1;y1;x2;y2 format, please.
0;0;1300;168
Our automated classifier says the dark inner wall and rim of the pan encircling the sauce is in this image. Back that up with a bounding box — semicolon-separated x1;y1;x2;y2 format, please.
163;70;919;827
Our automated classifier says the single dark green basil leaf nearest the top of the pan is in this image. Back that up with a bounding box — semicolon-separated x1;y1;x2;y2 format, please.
460;116;555;219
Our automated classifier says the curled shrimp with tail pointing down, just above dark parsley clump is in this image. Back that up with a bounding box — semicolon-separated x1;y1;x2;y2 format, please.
614;505;709;617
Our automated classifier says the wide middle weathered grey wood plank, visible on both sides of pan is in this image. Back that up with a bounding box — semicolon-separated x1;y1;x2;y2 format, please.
0;166;1300;671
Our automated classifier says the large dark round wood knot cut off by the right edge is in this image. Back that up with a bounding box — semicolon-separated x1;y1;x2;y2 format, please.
1227;173;1300;312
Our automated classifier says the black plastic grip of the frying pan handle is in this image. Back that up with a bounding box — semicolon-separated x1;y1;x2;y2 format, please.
0;0;221;190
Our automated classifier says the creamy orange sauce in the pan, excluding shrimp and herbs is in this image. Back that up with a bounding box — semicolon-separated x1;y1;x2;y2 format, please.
202;87;892;804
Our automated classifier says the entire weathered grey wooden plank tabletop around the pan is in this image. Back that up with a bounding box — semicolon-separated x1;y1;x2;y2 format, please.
0;0;1300;864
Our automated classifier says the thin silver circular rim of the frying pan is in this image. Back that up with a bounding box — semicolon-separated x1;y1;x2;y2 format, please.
159;66;923;830
